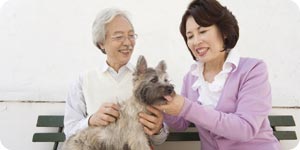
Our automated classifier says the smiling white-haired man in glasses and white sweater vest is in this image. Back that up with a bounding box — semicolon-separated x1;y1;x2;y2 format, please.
64;9;168;147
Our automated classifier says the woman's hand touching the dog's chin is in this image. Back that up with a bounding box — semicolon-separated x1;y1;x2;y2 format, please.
154;94;184;116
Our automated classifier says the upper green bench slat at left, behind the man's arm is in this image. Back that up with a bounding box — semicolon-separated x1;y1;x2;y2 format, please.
36;116;64;127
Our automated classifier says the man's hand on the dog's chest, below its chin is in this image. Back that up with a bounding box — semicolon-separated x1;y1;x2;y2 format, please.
139;106;164;135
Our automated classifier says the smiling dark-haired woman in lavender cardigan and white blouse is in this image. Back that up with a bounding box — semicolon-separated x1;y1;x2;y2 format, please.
156;0;279;150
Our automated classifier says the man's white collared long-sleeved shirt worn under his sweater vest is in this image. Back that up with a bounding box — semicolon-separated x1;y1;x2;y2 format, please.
64;63;169;145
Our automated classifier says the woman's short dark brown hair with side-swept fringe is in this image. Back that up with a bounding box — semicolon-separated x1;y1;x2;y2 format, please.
180;0;239;60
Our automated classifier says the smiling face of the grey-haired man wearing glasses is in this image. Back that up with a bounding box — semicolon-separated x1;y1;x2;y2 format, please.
100;16;136;67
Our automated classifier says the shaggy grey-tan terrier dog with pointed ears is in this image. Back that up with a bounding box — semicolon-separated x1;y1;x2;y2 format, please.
63;56;175;150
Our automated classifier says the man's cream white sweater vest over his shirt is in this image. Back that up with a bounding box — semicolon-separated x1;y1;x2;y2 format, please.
82;69;133;116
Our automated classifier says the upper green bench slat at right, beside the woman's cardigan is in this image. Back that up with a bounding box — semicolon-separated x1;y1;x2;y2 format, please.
269;116;296;127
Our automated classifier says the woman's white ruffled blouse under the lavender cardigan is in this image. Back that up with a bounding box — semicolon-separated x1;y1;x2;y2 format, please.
192;50;240;108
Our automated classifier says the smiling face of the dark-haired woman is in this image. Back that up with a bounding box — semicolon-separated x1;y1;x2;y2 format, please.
186;16;225;63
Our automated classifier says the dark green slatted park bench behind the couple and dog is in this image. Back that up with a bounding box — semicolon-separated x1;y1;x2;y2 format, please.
32;115;297;150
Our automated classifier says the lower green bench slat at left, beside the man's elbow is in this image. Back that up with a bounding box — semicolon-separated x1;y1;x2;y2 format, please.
32;133;66;142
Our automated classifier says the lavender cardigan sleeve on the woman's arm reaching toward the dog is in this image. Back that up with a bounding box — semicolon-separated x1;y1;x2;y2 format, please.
180;61;272;141
